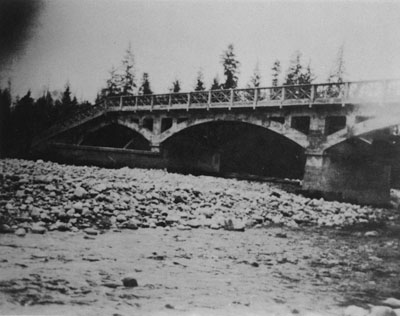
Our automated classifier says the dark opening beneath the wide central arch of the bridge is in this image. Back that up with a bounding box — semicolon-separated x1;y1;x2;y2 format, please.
162;121;305;178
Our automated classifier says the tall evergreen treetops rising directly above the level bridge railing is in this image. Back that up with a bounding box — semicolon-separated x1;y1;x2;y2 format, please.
96;44;345;97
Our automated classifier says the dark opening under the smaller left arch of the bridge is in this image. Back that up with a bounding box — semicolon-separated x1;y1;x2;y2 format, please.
80;123;150;150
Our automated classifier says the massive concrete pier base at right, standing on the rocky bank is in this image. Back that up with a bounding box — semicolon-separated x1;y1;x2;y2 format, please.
302;153;391;205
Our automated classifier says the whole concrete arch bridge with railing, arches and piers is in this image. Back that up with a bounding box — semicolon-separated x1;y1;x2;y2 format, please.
32;80;400;204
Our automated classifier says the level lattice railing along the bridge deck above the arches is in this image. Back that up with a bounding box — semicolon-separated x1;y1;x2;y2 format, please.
106;80;400;110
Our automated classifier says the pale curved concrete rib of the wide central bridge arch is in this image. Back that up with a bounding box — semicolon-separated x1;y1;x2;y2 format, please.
157;115;309;148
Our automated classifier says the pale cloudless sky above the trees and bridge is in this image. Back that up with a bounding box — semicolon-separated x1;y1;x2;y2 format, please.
3;0;400;101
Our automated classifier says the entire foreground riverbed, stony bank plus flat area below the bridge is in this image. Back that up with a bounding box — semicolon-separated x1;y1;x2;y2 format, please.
0;159;400;316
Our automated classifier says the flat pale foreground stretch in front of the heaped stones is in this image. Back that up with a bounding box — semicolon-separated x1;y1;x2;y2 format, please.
0;227;400;315
